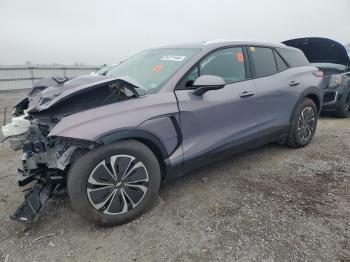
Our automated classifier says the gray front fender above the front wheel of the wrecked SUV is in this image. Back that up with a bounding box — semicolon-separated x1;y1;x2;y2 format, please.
49;92;180;155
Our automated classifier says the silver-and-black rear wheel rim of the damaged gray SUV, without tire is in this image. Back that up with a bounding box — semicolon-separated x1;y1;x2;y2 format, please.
297;106;316;142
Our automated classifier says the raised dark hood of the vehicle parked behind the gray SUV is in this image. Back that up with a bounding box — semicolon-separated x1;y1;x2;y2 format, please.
282;37;350;67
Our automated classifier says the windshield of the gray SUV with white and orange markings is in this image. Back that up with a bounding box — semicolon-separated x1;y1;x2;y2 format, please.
106;48;200;93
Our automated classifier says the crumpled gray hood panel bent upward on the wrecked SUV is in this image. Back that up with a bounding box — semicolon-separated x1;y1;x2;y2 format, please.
28;75;144;113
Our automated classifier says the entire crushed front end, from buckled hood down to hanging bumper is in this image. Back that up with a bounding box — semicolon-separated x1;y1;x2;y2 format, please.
2;76;139;223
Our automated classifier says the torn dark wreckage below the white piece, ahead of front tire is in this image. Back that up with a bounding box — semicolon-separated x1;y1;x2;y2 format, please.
10;135;96;223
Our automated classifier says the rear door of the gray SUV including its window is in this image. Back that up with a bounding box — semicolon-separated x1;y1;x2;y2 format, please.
248;46;303;130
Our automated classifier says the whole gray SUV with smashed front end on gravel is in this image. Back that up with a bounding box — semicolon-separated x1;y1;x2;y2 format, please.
2;41;323;225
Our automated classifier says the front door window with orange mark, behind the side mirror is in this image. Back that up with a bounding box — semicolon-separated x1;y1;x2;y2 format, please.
199;47;246;83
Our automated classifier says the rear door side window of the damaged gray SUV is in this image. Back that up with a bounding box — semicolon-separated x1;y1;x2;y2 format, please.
249;46;277;77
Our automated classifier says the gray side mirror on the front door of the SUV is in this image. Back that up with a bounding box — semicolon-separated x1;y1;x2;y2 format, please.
192;75;225;96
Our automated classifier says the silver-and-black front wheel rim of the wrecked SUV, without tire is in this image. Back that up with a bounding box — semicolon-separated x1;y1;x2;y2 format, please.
87;155;149;215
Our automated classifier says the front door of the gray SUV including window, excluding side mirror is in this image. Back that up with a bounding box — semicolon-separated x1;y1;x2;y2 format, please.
175;47;259;167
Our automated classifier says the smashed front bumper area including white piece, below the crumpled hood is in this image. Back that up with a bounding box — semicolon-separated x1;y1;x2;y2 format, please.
2;116;77;223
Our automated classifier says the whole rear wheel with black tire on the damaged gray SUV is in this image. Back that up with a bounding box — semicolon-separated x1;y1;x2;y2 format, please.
286;97;318;148
